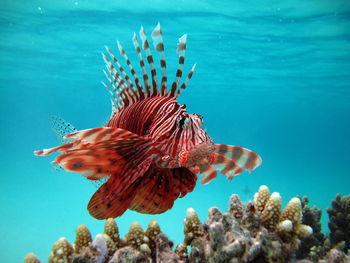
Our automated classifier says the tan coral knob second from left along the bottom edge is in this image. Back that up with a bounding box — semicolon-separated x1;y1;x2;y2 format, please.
49;237;74;263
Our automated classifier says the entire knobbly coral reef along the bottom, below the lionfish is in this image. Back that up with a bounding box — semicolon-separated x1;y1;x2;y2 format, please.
24;186;350;263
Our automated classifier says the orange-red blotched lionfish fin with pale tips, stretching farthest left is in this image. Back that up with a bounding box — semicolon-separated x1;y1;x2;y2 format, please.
35;127;153;179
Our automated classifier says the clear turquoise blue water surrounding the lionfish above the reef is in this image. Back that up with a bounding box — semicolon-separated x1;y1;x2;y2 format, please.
0;0;350;262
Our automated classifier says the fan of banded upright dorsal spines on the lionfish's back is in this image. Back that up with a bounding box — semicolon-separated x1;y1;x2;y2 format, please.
102;23;196;111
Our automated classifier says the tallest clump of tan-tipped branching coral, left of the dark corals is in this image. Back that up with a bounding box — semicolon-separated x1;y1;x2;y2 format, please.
189;191;310;263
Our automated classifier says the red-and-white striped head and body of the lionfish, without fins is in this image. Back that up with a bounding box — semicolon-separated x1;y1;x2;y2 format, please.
106;96;214;168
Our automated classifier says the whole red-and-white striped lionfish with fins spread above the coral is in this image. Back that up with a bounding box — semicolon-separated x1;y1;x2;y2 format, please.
35;23;261;219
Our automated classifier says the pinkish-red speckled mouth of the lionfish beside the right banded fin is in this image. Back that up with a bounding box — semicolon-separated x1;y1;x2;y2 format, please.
179;142;215;167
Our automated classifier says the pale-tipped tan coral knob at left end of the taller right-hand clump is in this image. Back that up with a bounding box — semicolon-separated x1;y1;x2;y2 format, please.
184;208;204;245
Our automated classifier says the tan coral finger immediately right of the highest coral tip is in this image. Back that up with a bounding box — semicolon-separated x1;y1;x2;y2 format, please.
261;192;282;231
